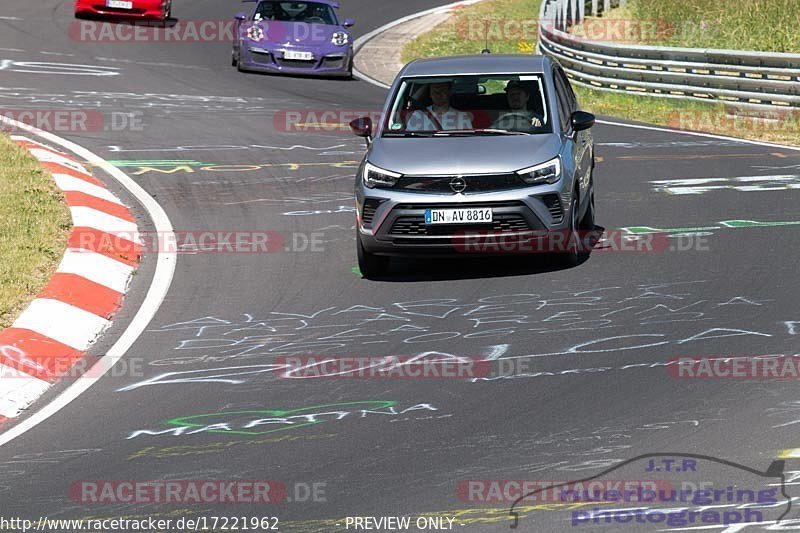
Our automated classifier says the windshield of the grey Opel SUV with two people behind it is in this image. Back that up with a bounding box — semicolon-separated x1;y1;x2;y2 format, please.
383;74;552;137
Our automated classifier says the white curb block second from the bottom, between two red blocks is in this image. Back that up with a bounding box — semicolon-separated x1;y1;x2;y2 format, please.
13;298;111;352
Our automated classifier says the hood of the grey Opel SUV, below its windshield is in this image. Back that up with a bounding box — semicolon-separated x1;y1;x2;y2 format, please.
368;134;561;175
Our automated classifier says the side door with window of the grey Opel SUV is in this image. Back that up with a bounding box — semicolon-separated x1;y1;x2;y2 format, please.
553;67;592;200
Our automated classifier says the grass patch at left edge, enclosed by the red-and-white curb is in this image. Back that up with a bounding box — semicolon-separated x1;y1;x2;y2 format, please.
0;134;71;330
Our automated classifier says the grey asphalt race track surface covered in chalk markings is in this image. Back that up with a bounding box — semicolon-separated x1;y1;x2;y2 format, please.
0;0;800;531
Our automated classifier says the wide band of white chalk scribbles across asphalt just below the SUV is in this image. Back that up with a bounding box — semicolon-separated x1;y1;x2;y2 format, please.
139;281;786;366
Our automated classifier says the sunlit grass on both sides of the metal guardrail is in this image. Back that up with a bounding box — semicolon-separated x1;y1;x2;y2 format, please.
402;0;800;146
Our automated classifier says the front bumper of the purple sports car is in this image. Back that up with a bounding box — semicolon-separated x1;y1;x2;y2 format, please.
239;46;353;76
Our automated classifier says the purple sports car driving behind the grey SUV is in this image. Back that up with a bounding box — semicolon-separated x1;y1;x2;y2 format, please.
232;0;354;77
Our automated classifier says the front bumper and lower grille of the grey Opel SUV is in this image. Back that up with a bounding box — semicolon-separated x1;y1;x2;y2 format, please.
356;184;572;255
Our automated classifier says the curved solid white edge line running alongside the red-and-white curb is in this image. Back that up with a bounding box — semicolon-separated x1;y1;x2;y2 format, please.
0;116;178;446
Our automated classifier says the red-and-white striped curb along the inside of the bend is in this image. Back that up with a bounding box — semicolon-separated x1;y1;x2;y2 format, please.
0;135;141;426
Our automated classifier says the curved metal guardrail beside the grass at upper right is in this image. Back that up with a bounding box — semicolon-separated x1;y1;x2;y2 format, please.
539;0;800;109
